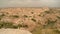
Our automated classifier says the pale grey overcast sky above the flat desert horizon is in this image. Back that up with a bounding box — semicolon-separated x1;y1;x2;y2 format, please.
0;0;60;7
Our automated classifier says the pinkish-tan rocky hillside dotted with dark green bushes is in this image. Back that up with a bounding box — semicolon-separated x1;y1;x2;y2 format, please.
0;8;60;34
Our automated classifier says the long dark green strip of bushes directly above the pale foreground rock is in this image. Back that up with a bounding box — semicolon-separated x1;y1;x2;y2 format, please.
0;22;28;29
